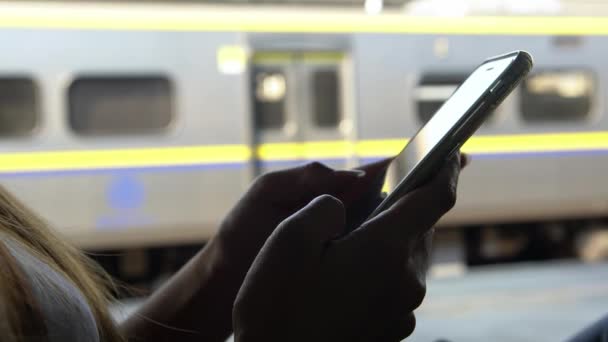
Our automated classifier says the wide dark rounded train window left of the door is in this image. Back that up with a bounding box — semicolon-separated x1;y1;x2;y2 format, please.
69;77;173;135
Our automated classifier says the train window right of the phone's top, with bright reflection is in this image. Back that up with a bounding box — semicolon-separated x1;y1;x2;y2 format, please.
520;71;595;122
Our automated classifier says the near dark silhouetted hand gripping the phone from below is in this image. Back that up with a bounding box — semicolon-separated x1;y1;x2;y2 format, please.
233;156;460;342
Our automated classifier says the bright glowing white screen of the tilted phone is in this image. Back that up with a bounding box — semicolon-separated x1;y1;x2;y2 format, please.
390;56;516;195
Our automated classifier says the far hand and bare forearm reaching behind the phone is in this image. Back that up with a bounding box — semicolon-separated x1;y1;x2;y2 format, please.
121;160;388;342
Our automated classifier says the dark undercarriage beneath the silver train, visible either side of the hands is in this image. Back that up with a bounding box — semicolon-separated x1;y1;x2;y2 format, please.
89;219;608;299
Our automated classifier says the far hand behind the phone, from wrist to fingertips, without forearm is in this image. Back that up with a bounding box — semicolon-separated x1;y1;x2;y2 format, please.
211;160;390;286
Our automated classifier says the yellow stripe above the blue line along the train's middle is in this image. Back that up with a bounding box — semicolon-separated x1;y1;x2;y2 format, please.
0;132;608;173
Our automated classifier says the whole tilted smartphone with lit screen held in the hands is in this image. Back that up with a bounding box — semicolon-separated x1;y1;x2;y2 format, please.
368;51;533;219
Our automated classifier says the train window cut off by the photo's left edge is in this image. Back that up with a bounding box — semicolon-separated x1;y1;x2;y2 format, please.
0;78;38;136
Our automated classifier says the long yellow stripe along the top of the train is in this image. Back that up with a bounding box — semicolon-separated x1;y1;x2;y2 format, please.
0;3;608;35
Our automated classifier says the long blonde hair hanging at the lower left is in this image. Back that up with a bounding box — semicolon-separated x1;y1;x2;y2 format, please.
0;186;125;342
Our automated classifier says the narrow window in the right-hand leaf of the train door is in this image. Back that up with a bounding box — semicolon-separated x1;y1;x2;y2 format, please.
312;70;341;127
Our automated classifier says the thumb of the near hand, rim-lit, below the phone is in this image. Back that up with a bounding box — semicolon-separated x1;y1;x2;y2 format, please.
243;195;345;283
